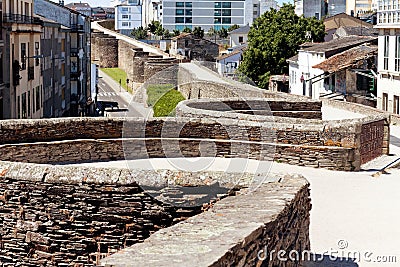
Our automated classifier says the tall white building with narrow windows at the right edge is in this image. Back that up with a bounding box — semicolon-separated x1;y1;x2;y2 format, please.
376;0;400;114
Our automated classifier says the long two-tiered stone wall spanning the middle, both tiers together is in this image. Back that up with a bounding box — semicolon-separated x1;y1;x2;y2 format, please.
0;117;382;171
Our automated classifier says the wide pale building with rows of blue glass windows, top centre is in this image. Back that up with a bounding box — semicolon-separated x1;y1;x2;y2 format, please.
162;0;255;31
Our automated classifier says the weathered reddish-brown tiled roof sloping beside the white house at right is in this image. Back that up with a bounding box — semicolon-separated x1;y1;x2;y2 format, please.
313;45;378;73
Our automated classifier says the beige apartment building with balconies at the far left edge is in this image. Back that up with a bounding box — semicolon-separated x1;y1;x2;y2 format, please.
2;0;43;119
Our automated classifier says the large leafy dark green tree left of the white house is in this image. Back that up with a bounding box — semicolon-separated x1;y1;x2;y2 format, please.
239;4;325;88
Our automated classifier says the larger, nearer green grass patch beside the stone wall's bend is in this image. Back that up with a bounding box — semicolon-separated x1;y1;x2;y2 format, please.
147;84;185;117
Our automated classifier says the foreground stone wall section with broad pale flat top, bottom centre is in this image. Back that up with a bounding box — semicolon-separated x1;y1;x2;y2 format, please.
102;175;311;267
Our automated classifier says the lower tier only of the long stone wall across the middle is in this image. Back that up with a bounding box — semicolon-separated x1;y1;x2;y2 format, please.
0;138;360;171
